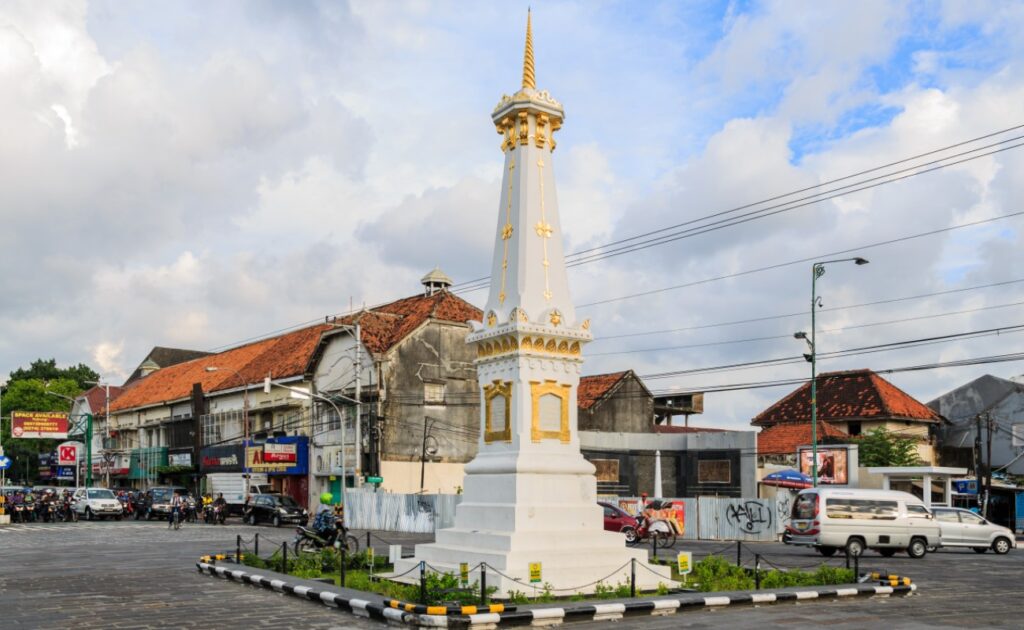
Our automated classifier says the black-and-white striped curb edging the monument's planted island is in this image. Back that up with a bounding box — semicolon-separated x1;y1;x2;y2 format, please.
196;561;918;628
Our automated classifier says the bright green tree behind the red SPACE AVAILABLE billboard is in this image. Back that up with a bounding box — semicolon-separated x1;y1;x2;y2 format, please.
0;378;82;484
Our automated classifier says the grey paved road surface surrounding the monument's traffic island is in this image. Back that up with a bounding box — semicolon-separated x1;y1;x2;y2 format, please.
0;521;1024;629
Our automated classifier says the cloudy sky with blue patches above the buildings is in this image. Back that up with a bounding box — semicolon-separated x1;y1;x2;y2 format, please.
0;0;1024;428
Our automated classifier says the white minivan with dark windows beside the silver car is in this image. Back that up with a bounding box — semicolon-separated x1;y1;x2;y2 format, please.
782;487;942;558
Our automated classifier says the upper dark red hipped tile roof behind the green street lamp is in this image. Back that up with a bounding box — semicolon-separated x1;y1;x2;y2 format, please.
751;370;941;426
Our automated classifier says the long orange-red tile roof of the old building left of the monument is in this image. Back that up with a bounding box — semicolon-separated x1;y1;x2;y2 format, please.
111;291;483;412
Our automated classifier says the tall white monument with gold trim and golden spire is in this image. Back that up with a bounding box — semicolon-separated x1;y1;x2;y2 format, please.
395;16;672;596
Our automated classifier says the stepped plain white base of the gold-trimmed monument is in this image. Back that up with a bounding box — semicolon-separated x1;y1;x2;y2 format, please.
395;457;674;597
